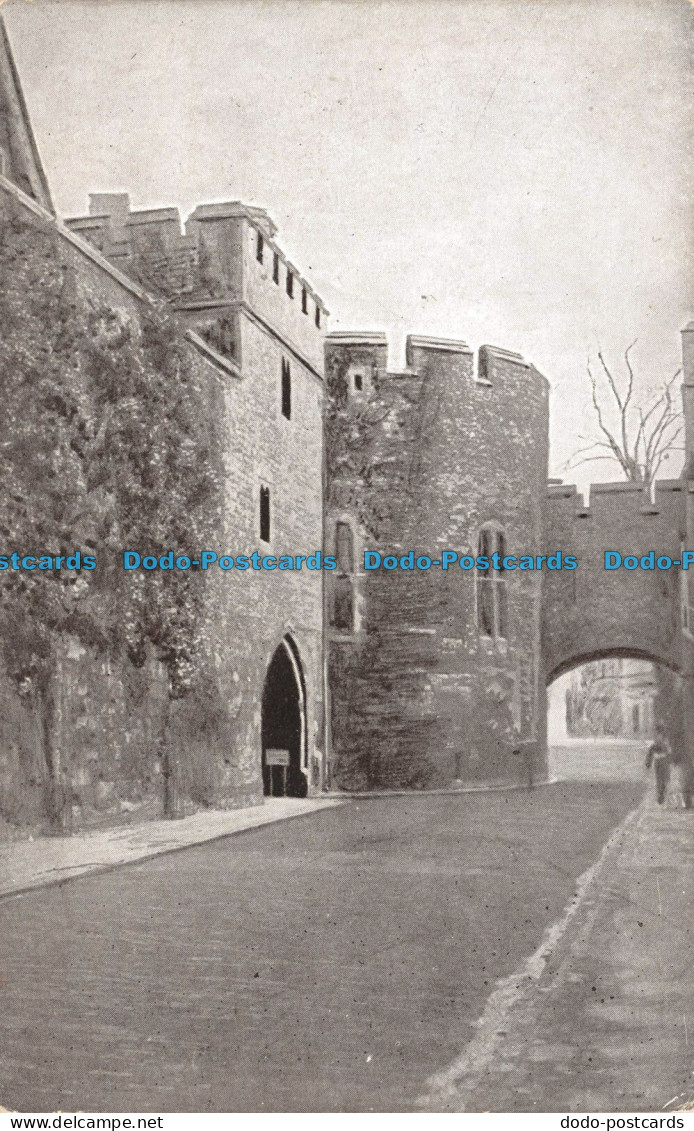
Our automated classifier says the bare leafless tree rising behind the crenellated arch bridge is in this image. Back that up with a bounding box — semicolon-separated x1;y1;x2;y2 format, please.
565;340;684;487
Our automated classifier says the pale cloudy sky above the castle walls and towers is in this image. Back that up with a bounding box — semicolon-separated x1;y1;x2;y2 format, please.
2;0;694;486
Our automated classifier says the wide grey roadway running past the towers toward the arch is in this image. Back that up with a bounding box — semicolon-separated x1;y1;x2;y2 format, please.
0;783;641;1112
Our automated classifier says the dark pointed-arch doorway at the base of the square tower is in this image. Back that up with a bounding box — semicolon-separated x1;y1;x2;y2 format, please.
262;639;307;797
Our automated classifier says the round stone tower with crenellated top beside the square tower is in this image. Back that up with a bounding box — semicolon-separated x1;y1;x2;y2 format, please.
326;335;547;788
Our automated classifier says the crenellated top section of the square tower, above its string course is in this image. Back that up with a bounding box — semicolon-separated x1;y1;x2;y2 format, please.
66;192;329;375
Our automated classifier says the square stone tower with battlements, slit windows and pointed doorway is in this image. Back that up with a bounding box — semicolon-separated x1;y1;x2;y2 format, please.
69;193;327;792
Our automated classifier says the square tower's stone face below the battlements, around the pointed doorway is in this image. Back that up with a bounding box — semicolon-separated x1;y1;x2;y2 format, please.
203;307;323;788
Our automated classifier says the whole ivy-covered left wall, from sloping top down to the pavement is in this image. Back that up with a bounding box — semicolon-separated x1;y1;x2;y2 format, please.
0;199;233;830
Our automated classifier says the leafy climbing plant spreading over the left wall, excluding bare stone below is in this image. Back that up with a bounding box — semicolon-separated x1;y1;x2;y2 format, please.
0;202;220;827
